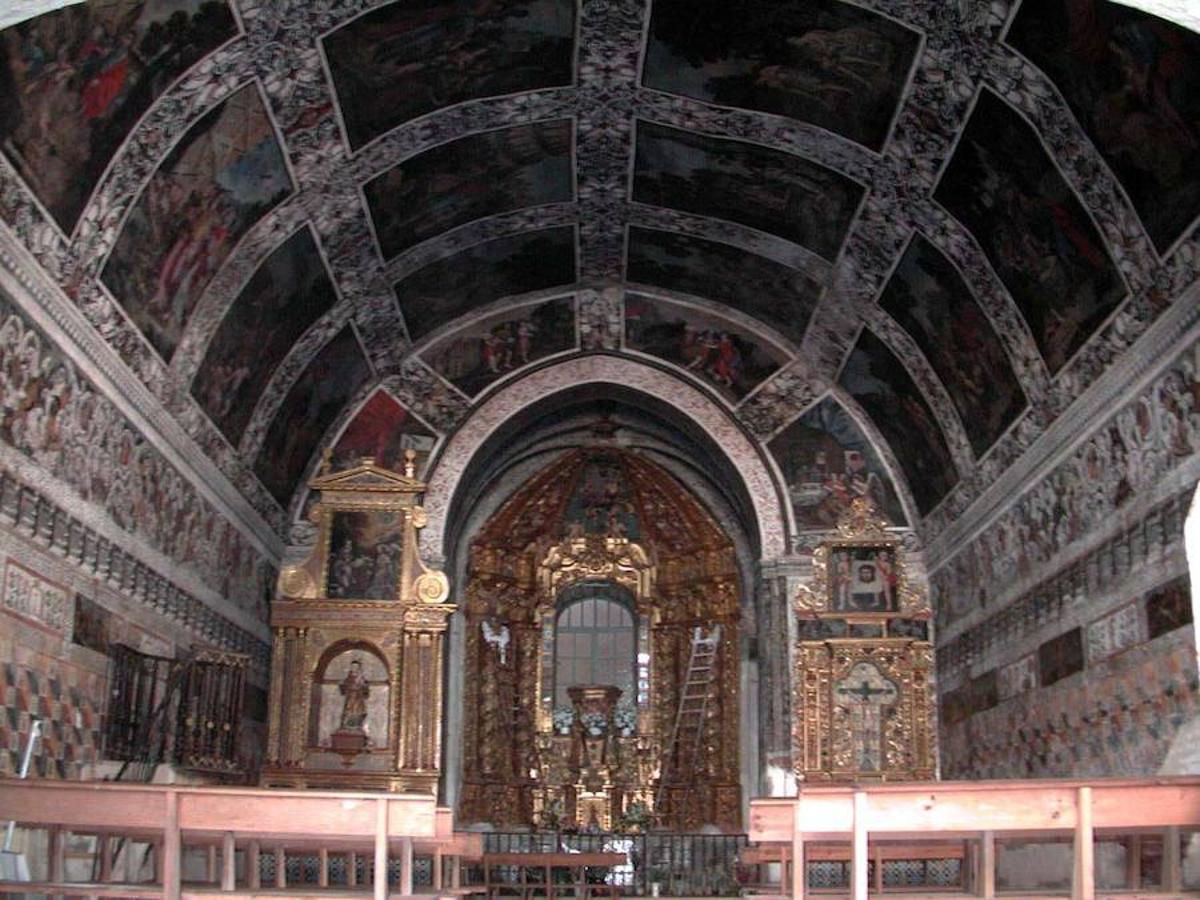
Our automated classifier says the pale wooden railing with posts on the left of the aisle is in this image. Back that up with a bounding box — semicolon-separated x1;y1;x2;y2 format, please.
0;779;482;900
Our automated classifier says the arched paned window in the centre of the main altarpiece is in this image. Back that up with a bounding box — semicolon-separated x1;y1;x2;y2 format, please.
554;586;637;707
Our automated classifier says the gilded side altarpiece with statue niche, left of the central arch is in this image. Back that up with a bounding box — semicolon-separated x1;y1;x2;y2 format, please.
263;451;455;793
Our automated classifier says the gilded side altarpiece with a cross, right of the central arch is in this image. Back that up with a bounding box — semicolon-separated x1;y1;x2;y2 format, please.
792;499;937;781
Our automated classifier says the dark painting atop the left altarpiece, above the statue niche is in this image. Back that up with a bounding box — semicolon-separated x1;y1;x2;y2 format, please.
325;510;403;600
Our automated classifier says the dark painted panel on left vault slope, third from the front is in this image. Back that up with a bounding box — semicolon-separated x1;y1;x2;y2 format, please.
191;228;337;446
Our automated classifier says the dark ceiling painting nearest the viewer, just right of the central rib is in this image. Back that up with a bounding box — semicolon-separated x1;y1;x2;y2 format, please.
642;0;919;149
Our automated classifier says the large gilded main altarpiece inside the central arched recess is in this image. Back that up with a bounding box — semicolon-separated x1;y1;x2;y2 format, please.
457;448;740;830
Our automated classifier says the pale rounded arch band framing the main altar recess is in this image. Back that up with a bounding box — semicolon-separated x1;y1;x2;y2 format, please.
421;356;786;559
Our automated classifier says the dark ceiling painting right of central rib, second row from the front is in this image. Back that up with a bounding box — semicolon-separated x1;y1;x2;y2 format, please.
634;121;863;259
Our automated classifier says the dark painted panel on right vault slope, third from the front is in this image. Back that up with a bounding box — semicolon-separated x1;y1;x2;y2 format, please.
880;235;1026;456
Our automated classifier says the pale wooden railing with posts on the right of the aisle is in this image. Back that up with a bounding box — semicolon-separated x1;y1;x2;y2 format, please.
750;778;1200;900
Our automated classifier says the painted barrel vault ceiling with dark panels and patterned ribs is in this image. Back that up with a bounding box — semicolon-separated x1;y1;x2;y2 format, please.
0;0;1200;564
